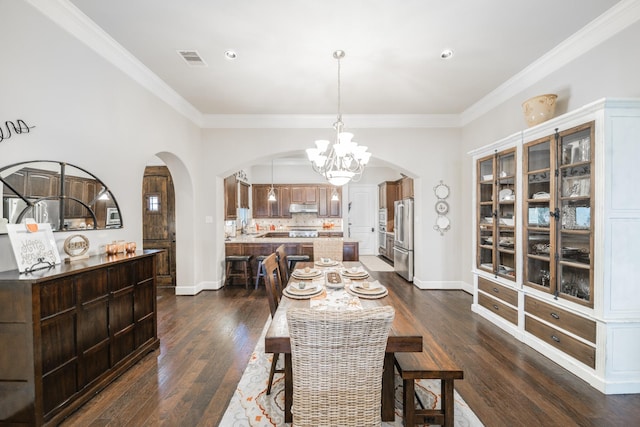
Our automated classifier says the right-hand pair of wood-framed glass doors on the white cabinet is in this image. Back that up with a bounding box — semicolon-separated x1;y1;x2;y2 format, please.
523;123;593;306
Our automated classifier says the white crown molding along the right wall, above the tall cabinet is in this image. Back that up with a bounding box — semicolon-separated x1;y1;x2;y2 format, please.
460;0;640;126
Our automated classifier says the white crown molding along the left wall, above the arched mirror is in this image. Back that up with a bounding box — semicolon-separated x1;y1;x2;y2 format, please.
27;0;202;126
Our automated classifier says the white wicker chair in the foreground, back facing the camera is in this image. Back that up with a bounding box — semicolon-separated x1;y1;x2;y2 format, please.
287;306;395;427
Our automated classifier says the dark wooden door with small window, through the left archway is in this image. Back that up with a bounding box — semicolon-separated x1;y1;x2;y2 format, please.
142;166;176;286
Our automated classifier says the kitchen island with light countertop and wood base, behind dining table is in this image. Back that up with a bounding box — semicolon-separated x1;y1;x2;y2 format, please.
225;231;359;281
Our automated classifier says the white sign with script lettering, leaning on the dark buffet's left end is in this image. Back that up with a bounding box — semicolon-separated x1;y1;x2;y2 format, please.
7;224;61;273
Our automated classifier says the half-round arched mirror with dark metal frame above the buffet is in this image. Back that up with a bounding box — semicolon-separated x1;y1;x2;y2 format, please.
0;160;122;231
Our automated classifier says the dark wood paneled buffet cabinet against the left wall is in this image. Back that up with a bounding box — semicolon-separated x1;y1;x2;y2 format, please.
0;251;160;426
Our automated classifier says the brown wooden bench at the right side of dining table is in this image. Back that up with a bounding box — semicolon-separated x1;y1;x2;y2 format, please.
395;348;464;427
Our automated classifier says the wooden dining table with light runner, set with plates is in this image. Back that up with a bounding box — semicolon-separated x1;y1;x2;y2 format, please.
264;262;423;423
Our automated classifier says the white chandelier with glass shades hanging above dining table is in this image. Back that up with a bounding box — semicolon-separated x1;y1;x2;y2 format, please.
307;50;371;186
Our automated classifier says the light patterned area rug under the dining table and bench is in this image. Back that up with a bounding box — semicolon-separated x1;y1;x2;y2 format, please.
220;322;482;427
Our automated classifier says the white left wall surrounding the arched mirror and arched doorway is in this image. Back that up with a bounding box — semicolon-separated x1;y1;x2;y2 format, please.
0;1;201;294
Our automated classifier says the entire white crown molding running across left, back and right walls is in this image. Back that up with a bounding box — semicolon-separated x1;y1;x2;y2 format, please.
27;0;640;129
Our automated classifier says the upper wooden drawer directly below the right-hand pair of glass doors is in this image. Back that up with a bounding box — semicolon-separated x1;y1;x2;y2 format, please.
524;296;596;344
